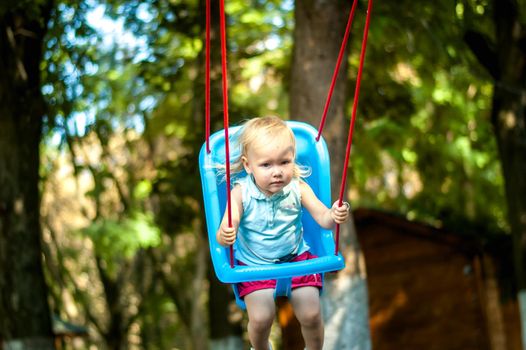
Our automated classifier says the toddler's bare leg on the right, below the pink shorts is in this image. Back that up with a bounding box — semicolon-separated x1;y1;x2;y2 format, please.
290;287;323;350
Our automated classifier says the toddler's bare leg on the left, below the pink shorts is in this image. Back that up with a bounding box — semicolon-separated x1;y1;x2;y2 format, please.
245;289;276;350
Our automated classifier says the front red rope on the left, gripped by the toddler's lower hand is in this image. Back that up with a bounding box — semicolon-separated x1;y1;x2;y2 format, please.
219;0;234;267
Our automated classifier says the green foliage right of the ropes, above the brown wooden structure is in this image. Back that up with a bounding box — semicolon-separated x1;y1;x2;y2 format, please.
342;1;507;235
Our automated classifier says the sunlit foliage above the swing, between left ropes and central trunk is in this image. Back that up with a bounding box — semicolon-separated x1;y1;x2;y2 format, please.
226;1;293;119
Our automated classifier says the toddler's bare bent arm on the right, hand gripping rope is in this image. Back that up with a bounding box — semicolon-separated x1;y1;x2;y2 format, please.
300;181;349;229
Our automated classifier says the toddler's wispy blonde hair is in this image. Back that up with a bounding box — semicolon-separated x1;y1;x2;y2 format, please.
230;116;310;178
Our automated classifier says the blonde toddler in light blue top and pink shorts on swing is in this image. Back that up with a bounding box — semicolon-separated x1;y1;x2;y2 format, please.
216;117;349;350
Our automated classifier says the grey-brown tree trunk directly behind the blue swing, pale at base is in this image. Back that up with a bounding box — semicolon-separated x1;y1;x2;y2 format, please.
290;0;370;350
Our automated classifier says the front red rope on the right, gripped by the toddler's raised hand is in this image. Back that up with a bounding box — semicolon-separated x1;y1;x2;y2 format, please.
334;0;373;255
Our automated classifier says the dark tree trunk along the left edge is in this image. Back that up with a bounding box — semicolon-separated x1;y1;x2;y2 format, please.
0;1;54;349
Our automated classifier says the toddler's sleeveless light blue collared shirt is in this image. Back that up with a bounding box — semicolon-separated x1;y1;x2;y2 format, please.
235;175;309;265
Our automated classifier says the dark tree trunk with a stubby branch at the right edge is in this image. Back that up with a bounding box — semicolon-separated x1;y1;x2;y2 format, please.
465;0;526;349
